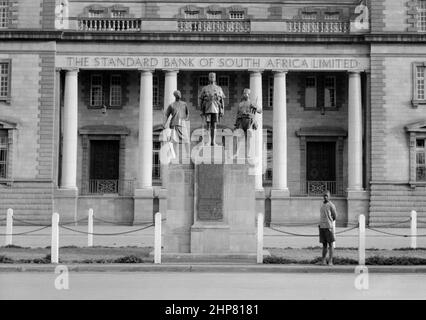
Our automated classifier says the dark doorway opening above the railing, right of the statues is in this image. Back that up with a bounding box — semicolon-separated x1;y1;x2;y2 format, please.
306;142;336;181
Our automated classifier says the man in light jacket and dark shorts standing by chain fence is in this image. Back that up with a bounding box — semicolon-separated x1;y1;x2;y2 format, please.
319;190;337;266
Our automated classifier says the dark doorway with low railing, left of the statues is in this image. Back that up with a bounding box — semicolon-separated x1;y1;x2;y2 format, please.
89;140;120;193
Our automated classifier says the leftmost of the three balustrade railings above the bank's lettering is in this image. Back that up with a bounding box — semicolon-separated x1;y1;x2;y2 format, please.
78;18;141;32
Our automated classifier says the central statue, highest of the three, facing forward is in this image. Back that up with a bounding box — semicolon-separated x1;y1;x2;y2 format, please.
198;72;225;146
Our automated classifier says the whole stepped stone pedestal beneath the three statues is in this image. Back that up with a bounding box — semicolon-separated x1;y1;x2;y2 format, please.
164;146;257;262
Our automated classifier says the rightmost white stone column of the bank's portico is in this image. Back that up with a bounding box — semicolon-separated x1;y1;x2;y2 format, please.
348;72;363;191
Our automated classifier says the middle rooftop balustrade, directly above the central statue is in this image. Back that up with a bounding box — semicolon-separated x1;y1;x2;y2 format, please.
178;20;250;33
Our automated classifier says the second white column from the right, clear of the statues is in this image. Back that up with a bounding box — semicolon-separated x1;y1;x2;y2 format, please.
272;71;288;193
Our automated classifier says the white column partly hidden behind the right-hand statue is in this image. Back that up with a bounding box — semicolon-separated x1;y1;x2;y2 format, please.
250;70;263;190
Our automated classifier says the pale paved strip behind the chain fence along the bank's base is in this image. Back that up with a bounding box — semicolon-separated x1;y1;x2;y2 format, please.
0;225;426;249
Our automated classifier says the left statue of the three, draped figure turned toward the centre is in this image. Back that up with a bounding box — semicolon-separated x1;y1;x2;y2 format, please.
163;90;189;160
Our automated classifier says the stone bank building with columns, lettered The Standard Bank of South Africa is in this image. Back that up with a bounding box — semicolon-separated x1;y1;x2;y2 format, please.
0;0;426;226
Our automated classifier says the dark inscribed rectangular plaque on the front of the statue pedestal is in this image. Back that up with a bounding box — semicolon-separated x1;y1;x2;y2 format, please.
197;164;224;221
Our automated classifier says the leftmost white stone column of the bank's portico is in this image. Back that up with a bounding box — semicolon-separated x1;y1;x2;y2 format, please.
61;69;78;189
